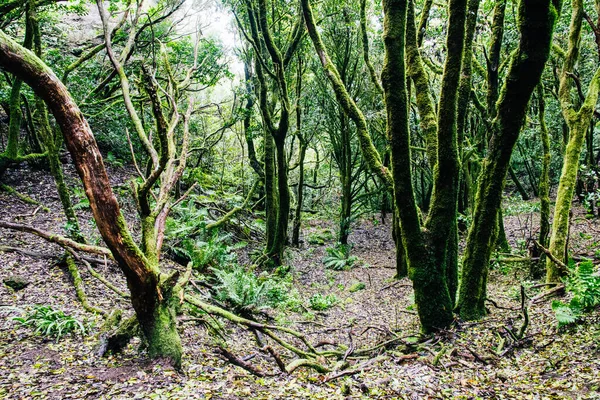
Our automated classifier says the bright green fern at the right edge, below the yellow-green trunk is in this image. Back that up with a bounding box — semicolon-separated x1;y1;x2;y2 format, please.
552;260;600;326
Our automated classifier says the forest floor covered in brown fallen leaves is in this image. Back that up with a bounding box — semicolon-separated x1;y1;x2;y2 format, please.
0;164;600;399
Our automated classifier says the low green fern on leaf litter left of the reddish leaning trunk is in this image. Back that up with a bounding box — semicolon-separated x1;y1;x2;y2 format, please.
12;306;87;341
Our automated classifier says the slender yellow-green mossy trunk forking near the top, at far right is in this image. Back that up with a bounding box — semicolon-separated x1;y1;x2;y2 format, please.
546;0;600;283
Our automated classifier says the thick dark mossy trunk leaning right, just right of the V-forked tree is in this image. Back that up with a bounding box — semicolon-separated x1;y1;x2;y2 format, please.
457;0;559;320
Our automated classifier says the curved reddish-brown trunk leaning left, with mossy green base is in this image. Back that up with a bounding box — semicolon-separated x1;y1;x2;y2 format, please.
0;31;182;367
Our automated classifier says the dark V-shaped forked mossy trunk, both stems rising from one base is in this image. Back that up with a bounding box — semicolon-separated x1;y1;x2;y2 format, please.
382;0;466;332
